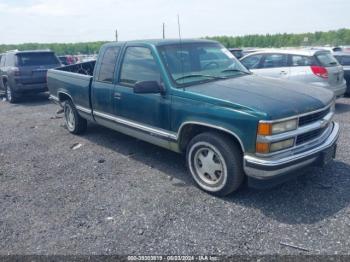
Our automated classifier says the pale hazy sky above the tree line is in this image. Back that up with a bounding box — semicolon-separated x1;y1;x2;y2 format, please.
0;0;350;44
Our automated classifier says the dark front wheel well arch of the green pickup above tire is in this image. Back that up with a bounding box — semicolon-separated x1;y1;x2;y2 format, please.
179;124;244;153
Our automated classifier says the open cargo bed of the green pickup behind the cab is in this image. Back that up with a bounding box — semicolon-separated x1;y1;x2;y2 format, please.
47;61;96;109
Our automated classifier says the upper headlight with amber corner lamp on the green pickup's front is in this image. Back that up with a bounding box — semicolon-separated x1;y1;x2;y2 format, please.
258;119;298;136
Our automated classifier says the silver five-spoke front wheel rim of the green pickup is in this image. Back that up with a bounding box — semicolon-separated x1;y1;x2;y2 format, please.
188;142;227;191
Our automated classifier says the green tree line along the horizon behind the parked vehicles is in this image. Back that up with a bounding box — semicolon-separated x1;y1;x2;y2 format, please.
0;28;350;55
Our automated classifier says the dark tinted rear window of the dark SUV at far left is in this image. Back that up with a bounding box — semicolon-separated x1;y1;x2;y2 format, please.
17;52;60;66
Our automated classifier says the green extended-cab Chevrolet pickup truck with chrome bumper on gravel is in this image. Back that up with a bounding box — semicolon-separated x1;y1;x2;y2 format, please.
47;40;339;196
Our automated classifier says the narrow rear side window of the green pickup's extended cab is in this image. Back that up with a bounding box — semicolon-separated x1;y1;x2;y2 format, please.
97;46;120;83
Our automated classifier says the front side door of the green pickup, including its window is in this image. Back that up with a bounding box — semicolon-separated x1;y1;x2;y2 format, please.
114;46;171;130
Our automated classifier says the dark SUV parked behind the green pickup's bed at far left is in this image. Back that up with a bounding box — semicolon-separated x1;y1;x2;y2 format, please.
0;50;61;103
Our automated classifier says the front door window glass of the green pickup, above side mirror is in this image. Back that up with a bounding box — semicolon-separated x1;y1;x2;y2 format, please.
120;47;160;86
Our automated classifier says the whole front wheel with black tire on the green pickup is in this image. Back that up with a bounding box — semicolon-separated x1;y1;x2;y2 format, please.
186;132;244;196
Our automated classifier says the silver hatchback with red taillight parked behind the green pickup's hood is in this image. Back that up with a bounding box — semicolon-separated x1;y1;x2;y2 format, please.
241;50;346;97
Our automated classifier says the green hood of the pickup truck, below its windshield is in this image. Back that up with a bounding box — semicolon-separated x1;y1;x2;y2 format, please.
186;75;334;120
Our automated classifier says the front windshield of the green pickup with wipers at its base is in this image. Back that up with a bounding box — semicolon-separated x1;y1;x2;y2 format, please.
158;43;250;86
